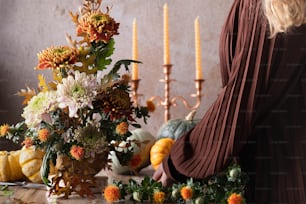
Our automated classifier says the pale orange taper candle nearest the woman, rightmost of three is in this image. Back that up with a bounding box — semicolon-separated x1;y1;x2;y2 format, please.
194;17;203;79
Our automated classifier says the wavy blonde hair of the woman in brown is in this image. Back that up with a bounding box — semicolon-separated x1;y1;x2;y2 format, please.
263;0;306;37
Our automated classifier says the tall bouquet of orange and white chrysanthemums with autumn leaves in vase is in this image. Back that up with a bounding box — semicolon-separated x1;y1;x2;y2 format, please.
1;0;154;197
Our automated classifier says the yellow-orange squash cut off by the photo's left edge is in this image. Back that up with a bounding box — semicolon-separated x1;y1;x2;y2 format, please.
0;150;25;182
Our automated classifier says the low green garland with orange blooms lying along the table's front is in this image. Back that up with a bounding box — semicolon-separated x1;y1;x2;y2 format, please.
103;164;248;204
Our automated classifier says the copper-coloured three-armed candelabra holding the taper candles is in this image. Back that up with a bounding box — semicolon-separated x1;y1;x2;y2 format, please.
131;64;205;122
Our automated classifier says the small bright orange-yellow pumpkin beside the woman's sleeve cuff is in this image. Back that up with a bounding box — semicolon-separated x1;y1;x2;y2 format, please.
150;138;175;170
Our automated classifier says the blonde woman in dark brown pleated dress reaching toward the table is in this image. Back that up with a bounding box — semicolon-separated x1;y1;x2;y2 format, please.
153;0;306;204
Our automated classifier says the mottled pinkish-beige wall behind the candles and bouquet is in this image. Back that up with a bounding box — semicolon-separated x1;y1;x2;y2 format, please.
0;0;233;135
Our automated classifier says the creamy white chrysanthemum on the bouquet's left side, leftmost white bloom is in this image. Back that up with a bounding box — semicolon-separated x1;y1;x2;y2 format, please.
22;91;57;127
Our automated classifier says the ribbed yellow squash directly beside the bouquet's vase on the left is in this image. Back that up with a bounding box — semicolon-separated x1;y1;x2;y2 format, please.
19;146;45;183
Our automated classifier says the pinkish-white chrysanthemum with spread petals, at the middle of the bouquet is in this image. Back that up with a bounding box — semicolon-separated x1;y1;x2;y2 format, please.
57;71;97;118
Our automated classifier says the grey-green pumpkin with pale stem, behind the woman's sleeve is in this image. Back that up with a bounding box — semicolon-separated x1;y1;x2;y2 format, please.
157;110;199;140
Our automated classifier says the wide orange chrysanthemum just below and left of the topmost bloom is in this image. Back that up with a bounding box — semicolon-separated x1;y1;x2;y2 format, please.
35;46;77;70
